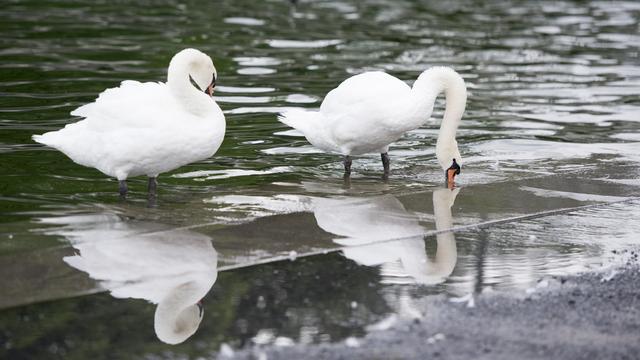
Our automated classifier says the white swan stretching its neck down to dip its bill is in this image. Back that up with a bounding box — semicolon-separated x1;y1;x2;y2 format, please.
279;67;467;183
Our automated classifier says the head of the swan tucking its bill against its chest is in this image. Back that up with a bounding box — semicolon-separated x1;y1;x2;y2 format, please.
168;49;218;96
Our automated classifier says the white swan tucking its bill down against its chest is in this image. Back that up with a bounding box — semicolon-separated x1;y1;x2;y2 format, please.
33;49;225;196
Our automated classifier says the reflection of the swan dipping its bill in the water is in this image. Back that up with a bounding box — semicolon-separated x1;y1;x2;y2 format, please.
314;188;460;285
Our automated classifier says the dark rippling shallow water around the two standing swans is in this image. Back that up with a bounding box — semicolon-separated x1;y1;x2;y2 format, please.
0;0;640;358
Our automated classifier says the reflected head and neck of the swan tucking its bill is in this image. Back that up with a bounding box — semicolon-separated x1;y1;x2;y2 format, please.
154;277;215;344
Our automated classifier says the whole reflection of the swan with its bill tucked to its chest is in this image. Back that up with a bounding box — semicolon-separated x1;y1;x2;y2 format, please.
44;214;218;344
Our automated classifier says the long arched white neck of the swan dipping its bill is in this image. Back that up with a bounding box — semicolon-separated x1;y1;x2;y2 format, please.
407;66;467;170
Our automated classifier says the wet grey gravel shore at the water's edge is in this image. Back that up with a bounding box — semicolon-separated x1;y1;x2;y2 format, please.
225;251;640;359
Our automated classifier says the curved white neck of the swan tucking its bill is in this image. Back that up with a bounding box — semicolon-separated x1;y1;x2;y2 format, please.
167;53;213;116
